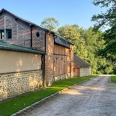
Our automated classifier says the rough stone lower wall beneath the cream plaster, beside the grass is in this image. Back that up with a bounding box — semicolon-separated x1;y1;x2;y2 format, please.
0;70;43;101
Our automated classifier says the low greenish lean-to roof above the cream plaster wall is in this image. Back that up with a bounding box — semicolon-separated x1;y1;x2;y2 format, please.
0;41;44;54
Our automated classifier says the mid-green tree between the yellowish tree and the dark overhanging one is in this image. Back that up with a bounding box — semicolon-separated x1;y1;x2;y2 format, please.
80;27;106;74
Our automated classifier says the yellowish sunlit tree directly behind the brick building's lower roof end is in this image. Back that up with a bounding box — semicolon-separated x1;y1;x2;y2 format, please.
58;25;87;58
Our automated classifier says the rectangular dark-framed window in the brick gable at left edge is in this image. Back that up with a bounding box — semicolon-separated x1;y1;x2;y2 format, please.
0;29;12;39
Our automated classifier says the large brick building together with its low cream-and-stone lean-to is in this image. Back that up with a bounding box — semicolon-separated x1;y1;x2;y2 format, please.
0;9;91;100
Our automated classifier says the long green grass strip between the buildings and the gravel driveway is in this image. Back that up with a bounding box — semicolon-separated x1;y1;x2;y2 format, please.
0;75;96;116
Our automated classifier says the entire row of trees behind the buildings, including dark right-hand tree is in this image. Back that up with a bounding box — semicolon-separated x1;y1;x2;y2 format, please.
40;0;116;74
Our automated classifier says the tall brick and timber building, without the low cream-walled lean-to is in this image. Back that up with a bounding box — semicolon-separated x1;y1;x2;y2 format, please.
0;9;73;86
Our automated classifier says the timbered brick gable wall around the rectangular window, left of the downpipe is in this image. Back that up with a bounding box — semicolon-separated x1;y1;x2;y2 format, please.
0;15;31;47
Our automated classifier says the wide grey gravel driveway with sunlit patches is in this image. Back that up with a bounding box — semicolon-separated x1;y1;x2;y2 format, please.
26;76;116;116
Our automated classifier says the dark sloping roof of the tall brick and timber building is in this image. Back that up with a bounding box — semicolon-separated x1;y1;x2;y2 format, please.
0;9;73;48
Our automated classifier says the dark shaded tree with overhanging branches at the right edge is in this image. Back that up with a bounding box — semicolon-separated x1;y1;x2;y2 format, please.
92;0;116;57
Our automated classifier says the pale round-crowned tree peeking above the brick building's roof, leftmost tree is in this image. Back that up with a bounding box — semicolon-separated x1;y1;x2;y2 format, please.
40;17;59;32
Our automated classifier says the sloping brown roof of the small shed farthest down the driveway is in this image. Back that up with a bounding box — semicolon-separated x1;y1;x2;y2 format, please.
74;55;91;68
